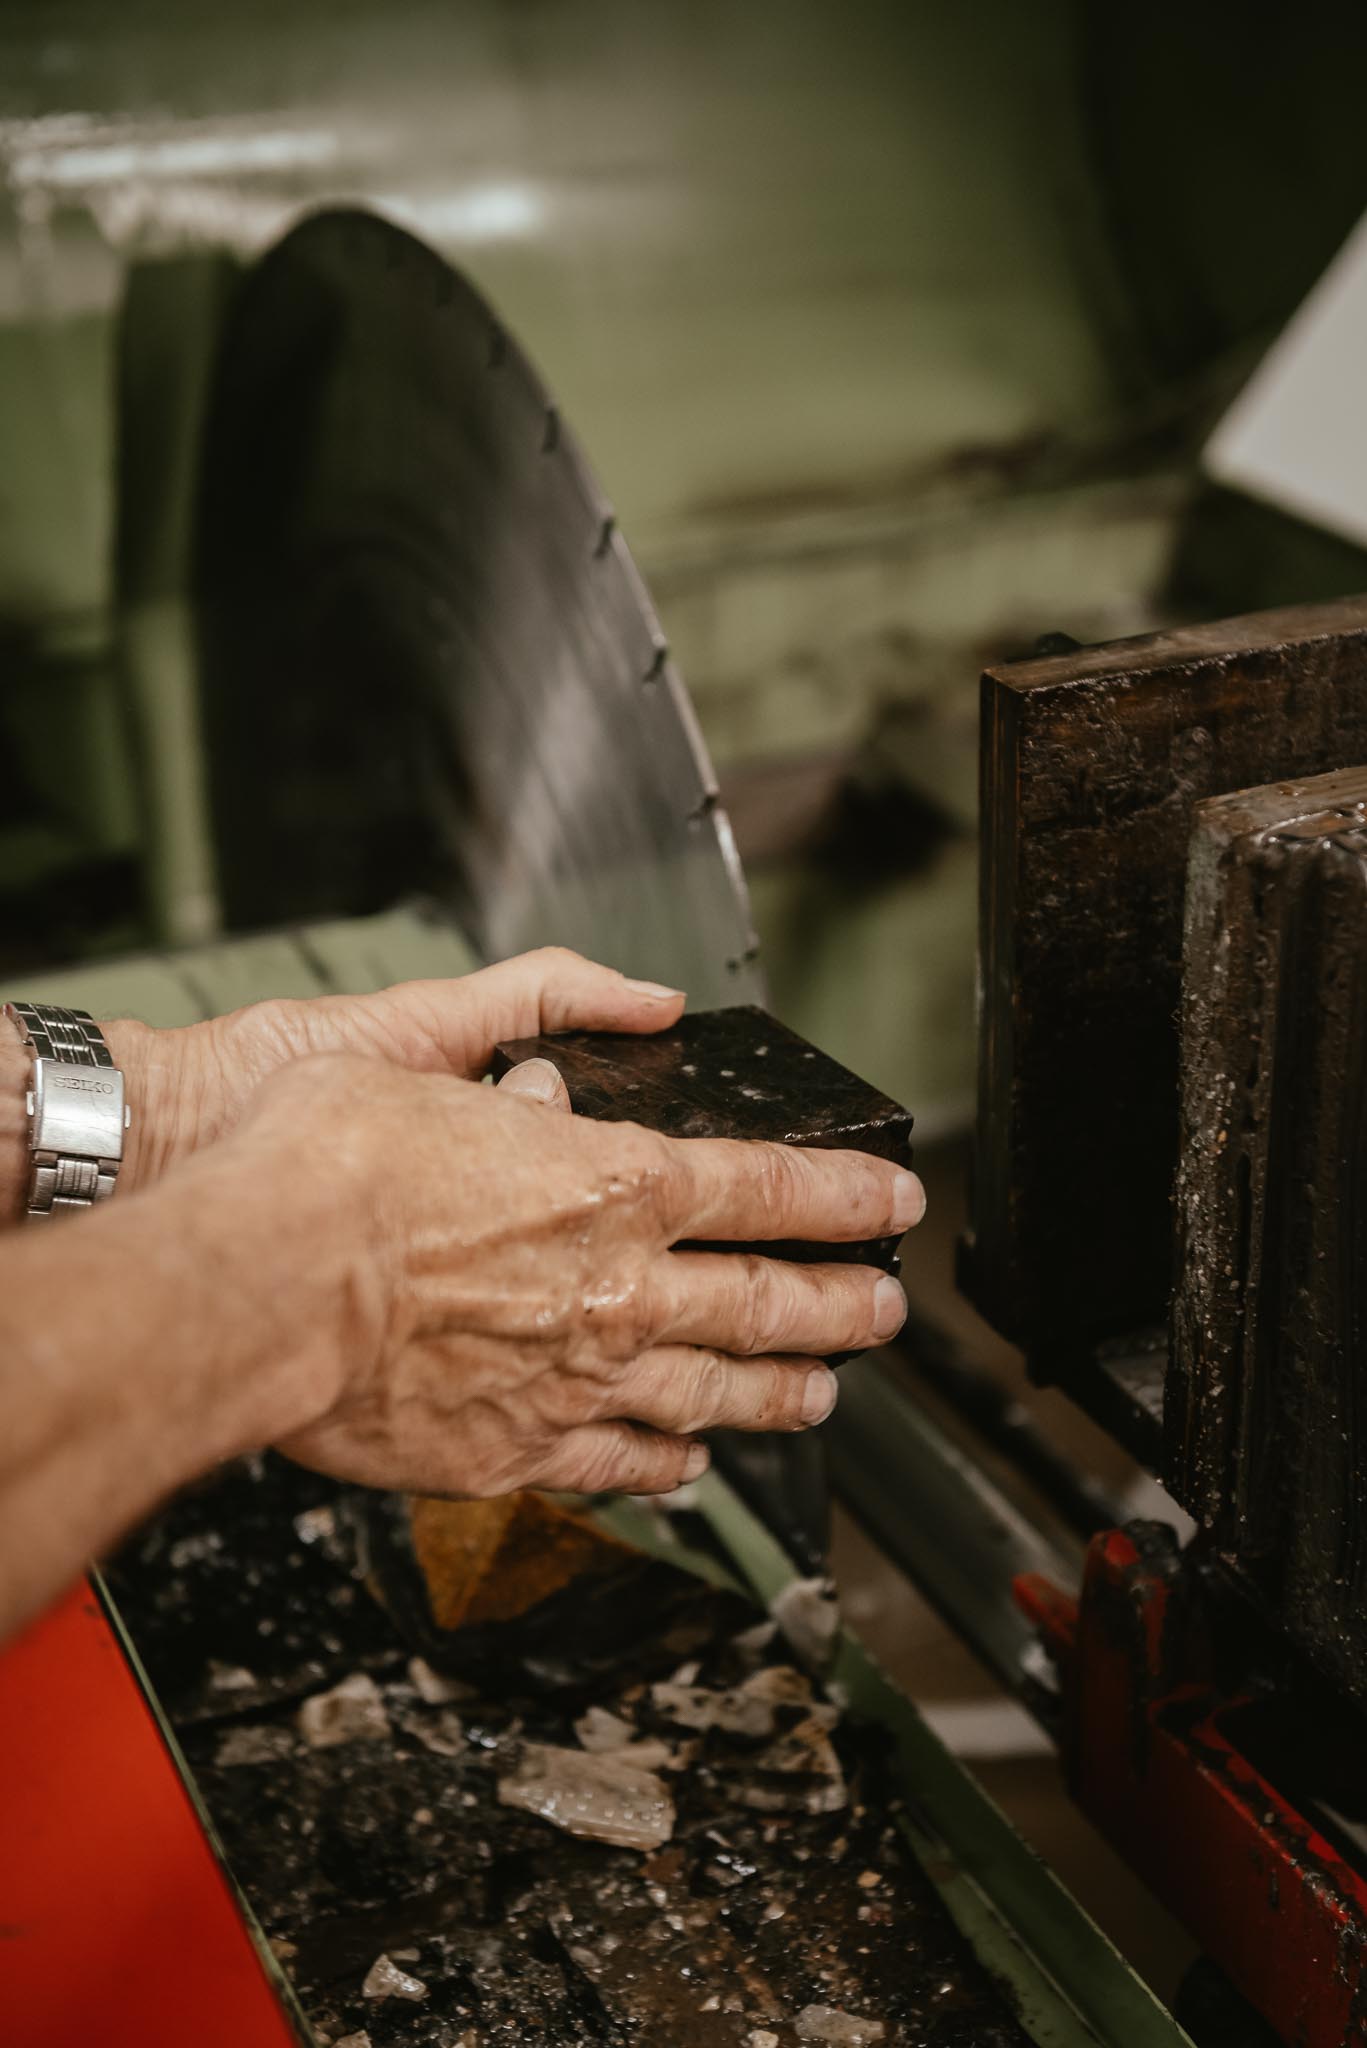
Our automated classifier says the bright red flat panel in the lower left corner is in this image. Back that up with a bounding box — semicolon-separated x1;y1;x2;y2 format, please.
0;1585;303;2048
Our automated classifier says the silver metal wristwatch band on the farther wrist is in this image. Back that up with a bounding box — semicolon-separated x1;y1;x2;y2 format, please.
4;1004;129;1217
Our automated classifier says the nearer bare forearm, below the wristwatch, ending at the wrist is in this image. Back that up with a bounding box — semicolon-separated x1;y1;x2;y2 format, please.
0;1139;355;1640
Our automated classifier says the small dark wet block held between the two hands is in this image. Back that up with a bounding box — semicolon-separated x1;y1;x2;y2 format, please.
494;1006;912;1272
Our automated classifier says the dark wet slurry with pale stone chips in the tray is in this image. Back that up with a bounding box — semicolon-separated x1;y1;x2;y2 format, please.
109;1458;1027;2048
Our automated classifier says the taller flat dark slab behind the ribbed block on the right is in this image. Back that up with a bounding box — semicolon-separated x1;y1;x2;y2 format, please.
963;598;1367;1372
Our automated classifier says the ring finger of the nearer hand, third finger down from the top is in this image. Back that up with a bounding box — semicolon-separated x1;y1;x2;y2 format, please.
607;1343;836;1436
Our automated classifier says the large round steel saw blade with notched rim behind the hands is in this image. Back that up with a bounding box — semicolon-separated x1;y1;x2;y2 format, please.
195;211;758;1008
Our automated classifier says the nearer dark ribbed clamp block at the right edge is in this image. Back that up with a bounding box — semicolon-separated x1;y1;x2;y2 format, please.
1166;768;1367;1702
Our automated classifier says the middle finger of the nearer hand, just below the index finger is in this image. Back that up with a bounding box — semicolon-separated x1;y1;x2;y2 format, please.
650;1251;906;1358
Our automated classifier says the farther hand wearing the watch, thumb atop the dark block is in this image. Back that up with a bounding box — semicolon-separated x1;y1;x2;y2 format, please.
105;946;685;1192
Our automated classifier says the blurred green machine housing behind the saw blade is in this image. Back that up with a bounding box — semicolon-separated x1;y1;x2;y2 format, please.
0;0;1367;1135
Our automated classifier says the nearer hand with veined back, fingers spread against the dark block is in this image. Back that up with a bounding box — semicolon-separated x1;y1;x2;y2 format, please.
245;1057;924;1495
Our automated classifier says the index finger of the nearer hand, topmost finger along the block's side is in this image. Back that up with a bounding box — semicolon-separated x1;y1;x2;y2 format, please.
670;1139;926;1245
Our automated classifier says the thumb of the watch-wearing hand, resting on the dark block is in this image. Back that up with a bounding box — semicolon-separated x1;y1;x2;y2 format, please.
365;946;685;1079
